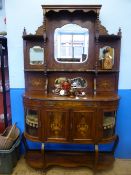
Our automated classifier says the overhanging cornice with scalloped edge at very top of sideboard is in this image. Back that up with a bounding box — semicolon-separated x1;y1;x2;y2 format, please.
42;5;101;14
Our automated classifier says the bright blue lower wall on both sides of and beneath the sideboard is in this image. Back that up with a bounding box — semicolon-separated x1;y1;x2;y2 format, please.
11;89;131;159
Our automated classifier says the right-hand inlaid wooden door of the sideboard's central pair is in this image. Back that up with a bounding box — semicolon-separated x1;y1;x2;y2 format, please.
71;109;96;143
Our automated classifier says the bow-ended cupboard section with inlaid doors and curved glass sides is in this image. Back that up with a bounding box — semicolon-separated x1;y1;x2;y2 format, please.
24;99;117;143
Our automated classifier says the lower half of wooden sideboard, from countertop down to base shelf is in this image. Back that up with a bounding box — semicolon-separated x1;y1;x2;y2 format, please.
23;97;118;169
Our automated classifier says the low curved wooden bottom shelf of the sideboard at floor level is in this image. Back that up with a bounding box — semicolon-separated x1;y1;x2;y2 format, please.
25;150;115;170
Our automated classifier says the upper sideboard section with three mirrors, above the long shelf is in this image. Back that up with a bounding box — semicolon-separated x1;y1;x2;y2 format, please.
23;5;121;72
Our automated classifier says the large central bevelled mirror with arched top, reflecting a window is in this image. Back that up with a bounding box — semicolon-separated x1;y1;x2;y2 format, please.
54;24;89;63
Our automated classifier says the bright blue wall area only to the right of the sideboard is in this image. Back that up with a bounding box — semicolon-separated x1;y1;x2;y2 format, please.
116;90;131;158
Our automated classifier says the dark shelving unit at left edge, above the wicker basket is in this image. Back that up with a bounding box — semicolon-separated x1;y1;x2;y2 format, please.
0;36;11;133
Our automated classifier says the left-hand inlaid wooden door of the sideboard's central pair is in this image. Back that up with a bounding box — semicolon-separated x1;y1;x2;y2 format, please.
44;109;69;142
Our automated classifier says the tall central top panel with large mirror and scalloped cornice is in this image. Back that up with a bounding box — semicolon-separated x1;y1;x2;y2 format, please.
42;5;101;71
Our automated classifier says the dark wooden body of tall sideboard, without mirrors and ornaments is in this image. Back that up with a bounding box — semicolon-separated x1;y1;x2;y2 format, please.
23;5;121;171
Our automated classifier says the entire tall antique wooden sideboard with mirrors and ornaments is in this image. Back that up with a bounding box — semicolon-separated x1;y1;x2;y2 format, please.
23;5;121;169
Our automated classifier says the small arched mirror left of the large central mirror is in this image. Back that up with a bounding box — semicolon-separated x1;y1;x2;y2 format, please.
30;46;44;65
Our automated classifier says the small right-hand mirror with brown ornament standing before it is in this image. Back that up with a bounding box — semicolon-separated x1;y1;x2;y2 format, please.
99;46;114;70
